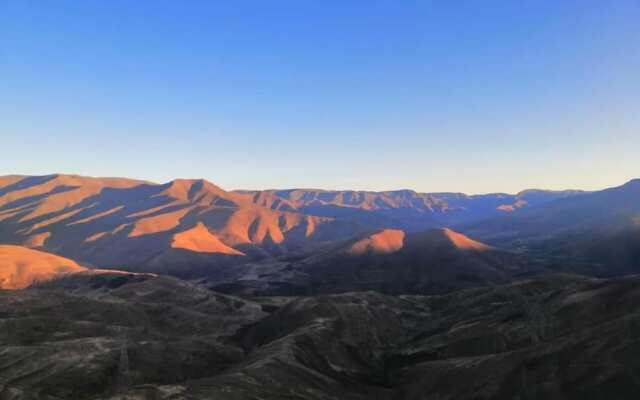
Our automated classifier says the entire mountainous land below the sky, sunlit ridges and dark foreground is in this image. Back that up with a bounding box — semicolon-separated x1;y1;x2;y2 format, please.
0;175;640;400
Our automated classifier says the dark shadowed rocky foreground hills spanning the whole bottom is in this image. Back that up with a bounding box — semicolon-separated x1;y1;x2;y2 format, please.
0;275;640;400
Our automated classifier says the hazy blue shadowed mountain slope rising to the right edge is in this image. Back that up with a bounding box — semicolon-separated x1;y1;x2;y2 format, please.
463;179;640;276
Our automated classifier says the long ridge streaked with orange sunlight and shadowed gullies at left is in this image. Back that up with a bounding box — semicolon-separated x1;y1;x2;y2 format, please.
0;175;358;274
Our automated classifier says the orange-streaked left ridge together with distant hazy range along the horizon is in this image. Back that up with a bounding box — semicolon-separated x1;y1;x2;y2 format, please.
0;175;592;273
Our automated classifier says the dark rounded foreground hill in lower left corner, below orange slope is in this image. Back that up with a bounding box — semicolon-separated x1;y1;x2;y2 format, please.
0;273;266;400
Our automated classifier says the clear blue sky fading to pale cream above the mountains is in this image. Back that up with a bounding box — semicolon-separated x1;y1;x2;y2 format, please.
0;0;640;193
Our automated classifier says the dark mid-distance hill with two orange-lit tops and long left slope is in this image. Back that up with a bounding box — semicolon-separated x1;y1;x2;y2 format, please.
210;228;532;295
